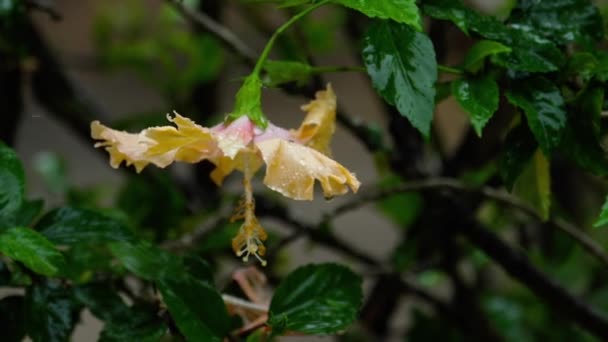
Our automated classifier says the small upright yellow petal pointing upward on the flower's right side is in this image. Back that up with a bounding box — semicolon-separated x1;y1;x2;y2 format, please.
295;84;336;155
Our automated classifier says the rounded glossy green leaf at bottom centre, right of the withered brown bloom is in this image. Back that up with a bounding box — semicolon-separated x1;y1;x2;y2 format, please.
268;264;363;334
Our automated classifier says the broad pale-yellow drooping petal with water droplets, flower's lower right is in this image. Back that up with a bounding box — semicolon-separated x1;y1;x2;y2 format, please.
256;139;360;200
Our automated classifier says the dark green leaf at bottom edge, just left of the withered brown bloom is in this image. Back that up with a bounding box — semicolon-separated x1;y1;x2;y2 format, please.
158;277;230;342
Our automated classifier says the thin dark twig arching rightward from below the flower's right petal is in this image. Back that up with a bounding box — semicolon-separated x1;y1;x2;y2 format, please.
325;178;608;266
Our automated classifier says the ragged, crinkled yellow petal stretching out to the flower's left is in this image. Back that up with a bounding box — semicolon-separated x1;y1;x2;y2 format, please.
91;113;218;172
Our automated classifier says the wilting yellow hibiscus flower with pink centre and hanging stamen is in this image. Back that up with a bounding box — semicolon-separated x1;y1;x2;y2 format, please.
91;85;360;265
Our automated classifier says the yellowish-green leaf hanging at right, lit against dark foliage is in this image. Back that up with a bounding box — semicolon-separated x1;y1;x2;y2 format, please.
513;150;551;220
